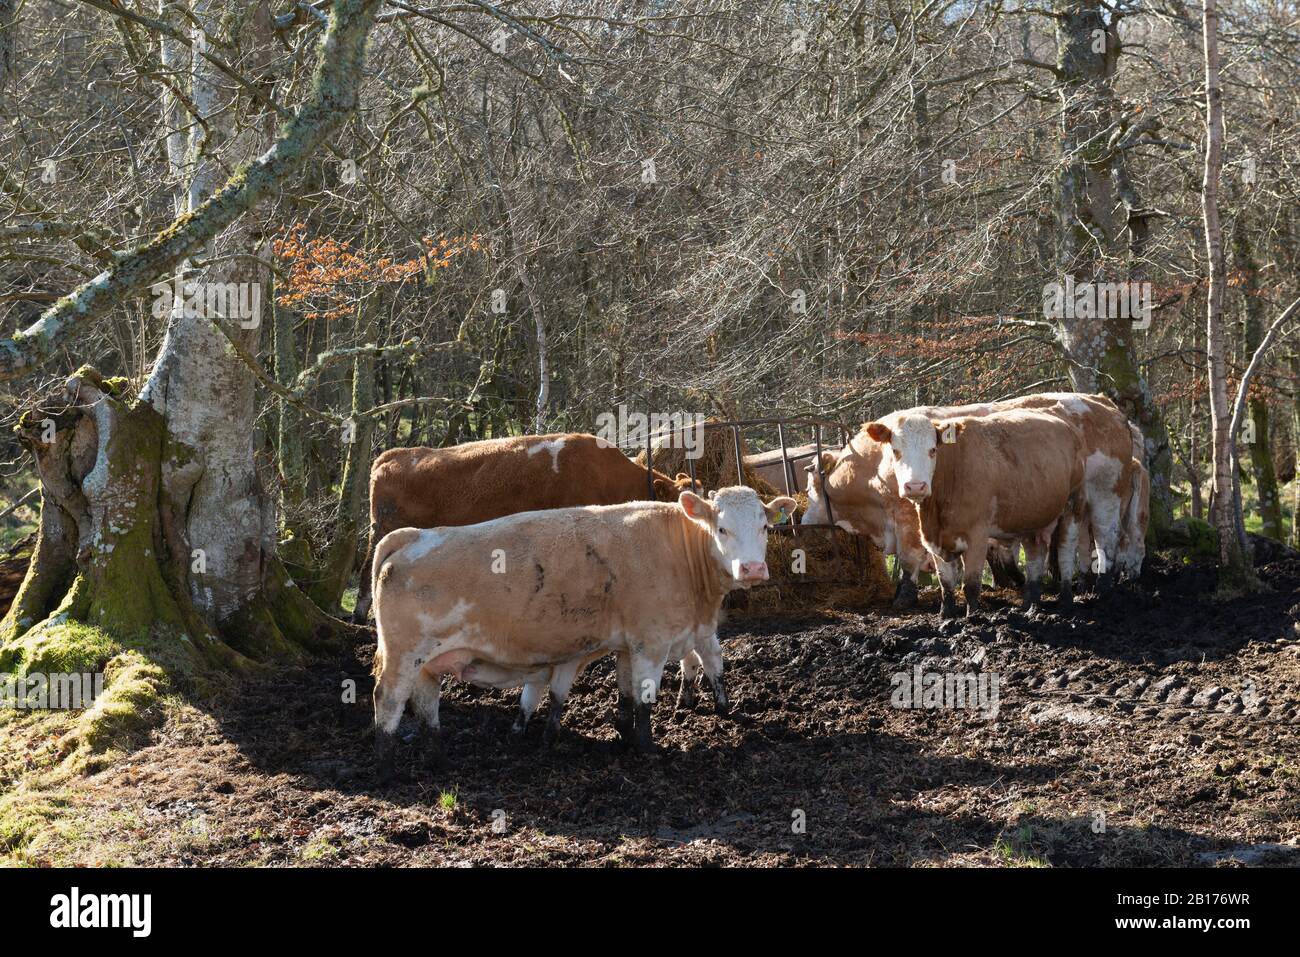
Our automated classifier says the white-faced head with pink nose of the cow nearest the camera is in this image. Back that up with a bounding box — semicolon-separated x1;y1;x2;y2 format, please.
677;485;796;586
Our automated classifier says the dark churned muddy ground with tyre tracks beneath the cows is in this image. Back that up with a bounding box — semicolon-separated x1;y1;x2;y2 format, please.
12;554;1300;866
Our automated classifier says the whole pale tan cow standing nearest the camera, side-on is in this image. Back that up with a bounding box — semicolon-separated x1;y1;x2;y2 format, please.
373;488;794;775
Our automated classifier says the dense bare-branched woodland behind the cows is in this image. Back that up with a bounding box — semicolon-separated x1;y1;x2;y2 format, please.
0;0;1300;634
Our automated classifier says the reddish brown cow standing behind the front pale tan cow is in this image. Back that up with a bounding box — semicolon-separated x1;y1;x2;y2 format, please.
352;433;690;623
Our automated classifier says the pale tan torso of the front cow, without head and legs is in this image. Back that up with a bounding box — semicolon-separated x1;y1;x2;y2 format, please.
376;502;720;667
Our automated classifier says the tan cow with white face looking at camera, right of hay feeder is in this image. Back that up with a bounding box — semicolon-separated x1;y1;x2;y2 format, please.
867;410;1087;618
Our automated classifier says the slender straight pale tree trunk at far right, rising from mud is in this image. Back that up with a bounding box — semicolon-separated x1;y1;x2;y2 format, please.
1201;0;1253;593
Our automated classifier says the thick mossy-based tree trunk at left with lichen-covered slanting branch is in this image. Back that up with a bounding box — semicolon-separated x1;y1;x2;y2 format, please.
0;0;374;752
